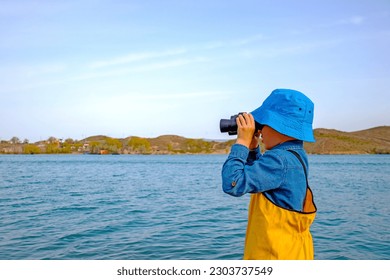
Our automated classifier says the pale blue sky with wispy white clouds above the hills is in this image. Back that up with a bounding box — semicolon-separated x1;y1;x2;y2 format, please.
0;0;390;141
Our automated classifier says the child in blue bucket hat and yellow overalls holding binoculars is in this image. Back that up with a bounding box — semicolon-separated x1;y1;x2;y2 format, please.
222;89;317;259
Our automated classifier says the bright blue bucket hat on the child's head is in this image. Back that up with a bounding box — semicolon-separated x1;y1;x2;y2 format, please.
251;89;315;142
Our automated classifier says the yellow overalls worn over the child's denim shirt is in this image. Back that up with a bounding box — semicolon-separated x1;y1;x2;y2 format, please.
244;187;317;260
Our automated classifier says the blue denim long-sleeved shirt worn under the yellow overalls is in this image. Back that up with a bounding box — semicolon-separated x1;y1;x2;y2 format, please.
222;140;309;211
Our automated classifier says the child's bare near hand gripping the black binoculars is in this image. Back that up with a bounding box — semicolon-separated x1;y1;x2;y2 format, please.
236;113;259;149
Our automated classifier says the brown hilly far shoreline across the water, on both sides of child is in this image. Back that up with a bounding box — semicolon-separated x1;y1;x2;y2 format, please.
0;126;390;154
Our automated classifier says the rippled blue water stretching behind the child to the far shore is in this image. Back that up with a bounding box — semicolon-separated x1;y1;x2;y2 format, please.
0;155;390;260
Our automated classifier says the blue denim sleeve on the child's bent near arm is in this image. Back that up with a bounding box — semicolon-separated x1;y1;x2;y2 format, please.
222;144;286;196
